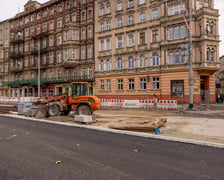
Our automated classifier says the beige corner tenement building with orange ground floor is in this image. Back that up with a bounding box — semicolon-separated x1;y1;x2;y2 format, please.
95;0;219;102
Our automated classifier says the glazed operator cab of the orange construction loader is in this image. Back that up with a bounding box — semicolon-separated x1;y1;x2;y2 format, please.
71;82;88;97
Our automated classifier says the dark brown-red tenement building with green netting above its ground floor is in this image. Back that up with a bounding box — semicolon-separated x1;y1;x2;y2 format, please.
6;0;95;97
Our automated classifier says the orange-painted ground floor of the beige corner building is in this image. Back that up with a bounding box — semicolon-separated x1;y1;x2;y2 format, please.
95;70;215;103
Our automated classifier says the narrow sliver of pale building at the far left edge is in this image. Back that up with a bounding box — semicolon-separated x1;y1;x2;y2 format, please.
0;20;9;96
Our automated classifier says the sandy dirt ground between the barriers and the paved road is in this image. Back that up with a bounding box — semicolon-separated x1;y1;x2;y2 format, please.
44;110;224;143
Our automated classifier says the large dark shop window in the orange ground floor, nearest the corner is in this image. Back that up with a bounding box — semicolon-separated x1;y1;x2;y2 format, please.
171;80;184;97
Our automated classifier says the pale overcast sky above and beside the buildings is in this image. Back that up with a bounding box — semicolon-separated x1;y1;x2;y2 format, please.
0;0;224;56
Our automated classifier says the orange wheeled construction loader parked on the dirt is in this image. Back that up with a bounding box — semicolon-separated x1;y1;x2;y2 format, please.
41;82;100;116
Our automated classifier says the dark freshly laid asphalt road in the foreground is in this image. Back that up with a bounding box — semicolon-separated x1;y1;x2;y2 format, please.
0;117;224;180
